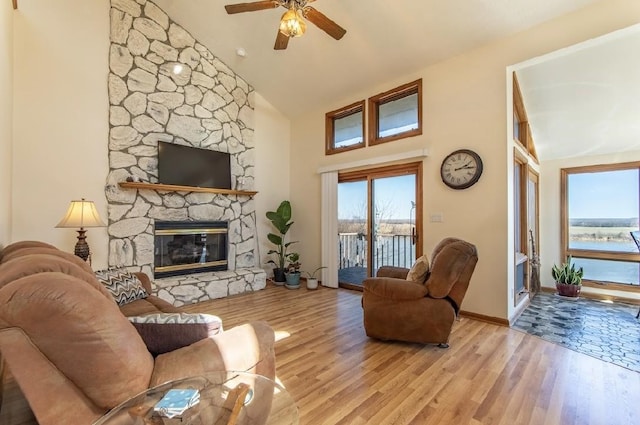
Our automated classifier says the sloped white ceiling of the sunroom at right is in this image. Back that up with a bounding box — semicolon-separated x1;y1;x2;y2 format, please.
517;25;640;160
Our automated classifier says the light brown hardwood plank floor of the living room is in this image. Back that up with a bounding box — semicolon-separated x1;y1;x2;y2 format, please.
0;286;640;425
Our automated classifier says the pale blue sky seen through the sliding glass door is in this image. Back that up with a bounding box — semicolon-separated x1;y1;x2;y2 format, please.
338;175;415;220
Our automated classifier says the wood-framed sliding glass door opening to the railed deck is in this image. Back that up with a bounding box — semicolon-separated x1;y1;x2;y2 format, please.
338;162;422;286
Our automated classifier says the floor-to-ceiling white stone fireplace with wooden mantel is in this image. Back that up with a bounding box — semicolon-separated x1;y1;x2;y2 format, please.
105;0;266;305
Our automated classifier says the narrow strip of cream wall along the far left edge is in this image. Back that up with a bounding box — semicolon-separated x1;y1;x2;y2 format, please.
0;1;15;247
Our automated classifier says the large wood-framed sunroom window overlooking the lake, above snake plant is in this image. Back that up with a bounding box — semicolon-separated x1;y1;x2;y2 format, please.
561;162;640;290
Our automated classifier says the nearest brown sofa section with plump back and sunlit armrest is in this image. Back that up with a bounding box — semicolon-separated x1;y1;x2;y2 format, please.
0;272;275;425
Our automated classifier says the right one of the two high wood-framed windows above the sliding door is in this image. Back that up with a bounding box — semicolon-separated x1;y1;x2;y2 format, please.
369;79;422;145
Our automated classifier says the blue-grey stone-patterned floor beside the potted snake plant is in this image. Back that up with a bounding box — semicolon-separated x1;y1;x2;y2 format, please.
513;293;640;372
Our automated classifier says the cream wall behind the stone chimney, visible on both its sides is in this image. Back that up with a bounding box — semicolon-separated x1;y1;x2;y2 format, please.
13;0;290;269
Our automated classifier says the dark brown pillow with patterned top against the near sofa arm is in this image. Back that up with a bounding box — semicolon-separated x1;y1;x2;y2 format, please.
128;313;222;356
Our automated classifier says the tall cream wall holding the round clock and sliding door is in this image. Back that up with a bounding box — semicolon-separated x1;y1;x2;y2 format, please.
291;0;640;319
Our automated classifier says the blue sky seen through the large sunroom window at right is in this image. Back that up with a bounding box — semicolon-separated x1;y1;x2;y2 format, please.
569;168;640;218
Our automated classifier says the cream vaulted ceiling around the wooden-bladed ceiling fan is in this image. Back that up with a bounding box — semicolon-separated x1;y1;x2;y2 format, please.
155;0;597;118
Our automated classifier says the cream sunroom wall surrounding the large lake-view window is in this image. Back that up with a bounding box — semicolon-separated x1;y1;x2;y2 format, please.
540;151;640;299
